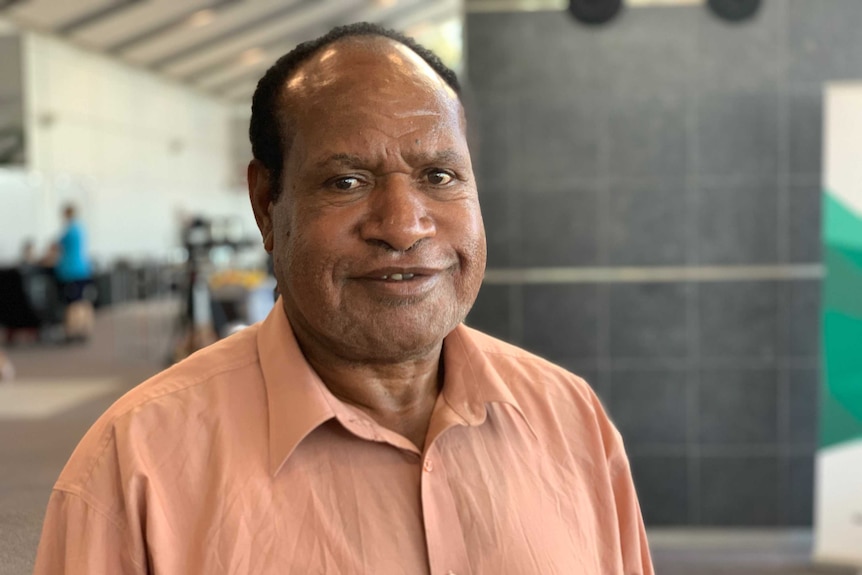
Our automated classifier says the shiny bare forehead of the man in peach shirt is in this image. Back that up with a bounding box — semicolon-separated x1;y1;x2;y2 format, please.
281;37;463;141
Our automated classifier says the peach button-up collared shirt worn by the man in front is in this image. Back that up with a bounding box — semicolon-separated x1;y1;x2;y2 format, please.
35;302;652;575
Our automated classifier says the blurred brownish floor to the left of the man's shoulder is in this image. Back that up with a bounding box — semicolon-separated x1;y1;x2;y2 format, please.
0;300;178;575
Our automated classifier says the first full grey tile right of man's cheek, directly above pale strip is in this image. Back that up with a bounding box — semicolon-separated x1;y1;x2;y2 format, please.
515;189;598;267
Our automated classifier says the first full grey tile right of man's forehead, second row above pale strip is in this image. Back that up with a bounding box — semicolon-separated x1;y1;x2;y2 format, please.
517;91;601;187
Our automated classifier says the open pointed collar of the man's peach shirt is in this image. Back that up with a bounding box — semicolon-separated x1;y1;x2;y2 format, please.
257;298;535;476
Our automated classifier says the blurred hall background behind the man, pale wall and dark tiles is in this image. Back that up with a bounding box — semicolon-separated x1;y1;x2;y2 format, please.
0;0;862;574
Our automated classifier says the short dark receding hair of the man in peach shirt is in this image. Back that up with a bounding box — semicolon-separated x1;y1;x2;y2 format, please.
248;22;461;201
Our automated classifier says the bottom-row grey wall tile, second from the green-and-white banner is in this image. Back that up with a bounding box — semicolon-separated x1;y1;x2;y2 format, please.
699;457;779;527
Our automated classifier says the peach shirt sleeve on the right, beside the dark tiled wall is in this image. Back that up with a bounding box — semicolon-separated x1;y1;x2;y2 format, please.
595;399;654;575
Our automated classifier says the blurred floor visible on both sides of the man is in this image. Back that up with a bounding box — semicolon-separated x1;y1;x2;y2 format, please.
0;301;857;575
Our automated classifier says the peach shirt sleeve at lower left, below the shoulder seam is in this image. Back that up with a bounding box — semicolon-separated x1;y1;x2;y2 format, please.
33;489;148;575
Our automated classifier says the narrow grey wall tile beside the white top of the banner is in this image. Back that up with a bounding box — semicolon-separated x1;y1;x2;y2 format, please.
787;84;823;175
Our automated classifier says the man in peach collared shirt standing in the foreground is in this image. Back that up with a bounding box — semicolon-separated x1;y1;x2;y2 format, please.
36;25;652;575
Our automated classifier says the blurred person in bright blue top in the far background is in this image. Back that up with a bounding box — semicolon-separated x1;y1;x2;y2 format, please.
54;204;93;341
